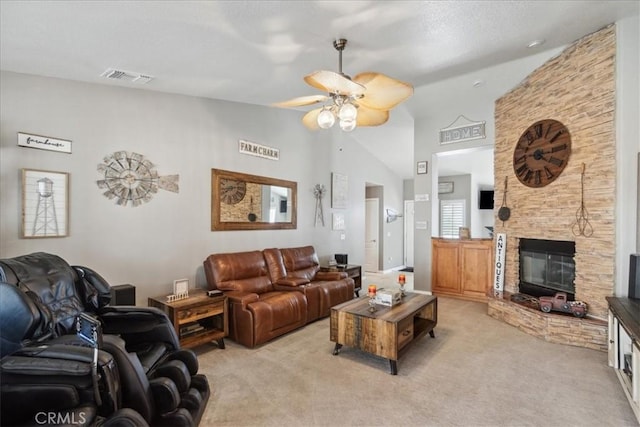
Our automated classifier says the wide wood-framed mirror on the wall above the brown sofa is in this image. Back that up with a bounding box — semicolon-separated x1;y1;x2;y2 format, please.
211;169;298;231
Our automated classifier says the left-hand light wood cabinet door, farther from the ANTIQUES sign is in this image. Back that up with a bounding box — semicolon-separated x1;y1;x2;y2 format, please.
431;241;460;294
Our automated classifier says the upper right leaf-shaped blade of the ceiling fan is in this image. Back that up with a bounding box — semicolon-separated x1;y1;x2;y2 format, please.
353;72;413;111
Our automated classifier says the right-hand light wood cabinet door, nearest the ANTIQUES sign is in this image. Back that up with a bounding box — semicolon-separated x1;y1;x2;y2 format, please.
460;242;492;298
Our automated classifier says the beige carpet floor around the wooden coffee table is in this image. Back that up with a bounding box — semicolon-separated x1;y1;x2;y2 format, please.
198;298;638;426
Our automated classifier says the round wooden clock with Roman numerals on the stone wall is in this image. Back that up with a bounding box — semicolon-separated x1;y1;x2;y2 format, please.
513;119;571;188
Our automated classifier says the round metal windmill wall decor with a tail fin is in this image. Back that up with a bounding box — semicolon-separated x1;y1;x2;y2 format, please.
96;151;180;207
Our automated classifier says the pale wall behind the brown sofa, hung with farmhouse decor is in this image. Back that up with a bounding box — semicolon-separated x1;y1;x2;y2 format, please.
0;72;403;305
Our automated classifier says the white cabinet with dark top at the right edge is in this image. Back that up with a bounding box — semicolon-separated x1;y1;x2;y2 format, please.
607;297;640;422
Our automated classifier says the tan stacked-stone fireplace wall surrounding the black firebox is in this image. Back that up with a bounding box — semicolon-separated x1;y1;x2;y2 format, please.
494;25;616;319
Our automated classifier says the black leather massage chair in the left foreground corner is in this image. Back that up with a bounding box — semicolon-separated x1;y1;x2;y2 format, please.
0;252;210;427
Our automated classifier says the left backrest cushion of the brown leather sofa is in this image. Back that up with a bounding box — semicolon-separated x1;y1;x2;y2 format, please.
204;251;273;294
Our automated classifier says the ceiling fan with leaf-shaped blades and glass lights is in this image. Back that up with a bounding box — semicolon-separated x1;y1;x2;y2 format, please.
273;39;413;132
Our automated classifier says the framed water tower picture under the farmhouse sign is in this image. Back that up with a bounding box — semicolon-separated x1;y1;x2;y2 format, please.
21;169;69;239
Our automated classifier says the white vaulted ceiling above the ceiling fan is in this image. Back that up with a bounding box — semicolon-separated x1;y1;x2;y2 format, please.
0;0;639;177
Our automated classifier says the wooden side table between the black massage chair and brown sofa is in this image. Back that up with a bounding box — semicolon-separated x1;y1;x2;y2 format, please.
148;289;229;348
